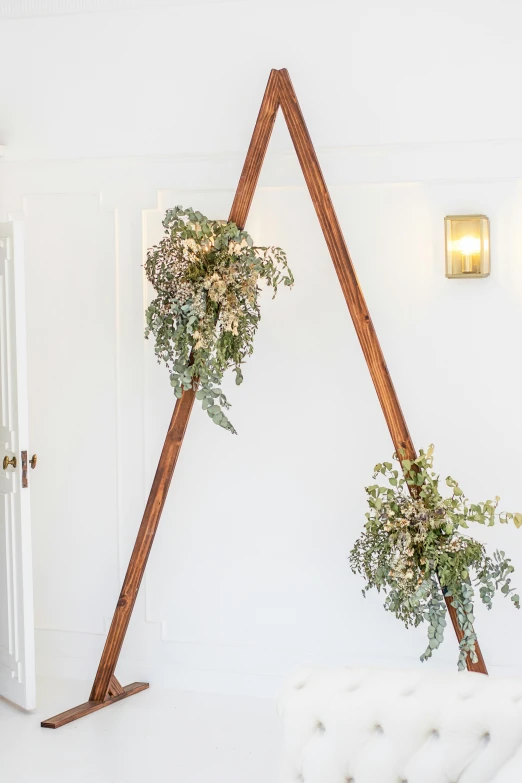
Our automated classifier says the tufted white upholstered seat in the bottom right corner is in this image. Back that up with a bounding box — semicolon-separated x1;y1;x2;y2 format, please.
279;668;522;783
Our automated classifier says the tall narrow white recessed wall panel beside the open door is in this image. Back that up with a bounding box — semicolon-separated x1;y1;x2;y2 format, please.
24;193;118;633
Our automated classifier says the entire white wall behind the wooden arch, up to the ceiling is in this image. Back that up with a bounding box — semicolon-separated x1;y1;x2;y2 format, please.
0;0;522;695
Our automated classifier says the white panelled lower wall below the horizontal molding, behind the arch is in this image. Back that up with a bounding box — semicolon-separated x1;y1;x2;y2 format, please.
0;143;522;695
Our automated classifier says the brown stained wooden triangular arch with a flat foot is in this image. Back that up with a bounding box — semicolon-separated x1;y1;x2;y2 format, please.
42;68;487;728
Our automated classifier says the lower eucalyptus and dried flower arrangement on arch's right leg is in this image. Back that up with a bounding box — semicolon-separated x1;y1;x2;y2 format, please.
350;446;522;669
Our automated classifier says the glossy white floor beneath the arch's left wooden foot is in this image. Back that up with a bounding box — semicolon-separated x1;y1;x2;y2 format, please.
0;680;281;783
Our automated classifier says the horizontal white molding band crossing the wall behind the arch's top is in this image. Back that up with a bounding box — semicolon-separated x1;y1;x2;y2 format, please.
5;141;522;190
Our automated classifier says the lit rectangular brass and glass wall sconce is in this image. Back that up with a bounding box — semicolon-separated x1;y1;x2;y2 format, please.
444;215;490;277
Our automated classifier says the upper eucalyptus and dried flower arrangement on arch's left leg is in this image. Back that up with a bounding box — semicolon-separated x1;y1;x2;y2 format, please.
145;206;294;433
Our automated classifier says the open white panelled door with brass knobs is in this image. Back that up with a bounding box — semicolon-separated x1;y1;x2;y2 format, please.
0;221;36;709
